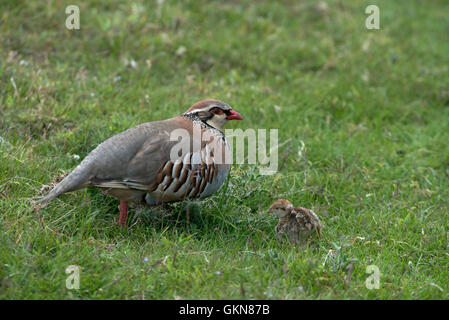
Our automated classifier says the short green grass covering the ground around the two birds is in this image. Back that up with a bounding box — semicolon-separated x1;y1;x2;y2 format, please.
0;0;449;299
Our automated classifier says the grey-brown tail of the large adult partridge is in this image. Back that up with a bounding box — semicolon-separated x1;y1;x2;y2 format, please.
38;158;92;204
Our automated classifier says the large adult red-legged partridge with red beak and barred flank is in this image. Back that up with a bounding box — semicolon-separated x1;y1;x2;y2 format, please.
40;100;243;225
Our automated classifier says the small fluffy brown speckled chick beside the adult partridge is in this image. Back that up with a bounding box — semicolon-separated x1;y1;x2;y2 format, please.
267;199;323;245
